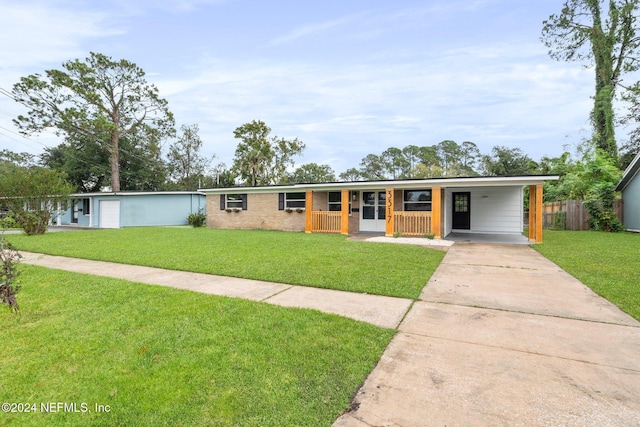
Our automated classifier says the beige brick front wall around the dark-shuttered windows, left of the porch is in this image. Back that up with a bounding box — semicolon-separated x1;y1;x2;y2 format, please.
207;193;304;231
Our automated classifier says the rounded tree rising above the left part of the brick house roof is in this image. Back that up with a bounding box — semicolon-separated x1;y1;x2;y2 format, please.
233;120;305;186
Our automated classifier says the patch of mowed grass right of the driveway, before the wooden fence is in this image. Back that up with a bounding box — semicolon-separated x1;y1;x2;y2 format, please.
533;230;640;320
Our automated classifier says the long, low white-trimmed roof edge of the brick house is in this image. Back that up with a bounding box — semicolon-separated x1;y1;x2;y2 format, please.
198;175;560;194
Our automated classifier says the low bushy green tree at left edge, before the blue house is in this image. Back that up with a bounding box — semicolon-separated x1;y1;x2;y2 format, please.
0;166;73;235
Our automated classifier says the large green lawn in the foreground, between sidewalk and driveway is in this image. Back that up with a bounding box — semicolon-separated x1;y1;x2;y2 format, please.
0;265;394;426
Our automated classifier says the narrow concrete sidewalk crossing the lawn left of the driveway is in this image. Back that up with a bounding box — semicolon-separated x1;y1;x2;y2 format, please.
20;251;413;329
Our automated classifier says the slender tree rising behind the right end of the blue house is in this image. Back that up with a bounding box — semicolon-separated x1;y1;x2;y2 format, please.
167;124;213;190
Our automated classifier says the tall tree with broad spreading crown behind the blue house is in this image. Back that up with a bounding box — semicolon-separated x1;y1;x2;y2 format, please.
13;52;175;191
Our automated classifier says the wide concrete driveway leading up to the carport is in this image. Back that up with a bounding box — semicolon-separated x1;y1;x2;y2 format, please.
334;243;640;427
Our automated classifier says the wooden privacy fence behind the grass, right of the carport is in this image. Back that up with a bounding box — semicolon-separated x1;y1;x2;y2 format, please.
542;200;623;230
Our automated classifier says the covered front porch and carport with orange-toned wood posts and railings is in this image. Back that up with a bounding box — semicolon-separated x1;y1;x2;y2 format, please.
305;184;543;243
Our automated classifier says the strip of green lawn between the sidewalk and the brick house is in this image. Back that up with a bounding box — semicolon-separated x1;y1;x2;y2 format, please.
7;227;444;299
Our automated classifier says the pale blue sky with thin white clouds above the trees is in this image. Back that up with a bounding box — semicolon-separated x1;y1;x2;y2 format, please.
0;0;593;173
